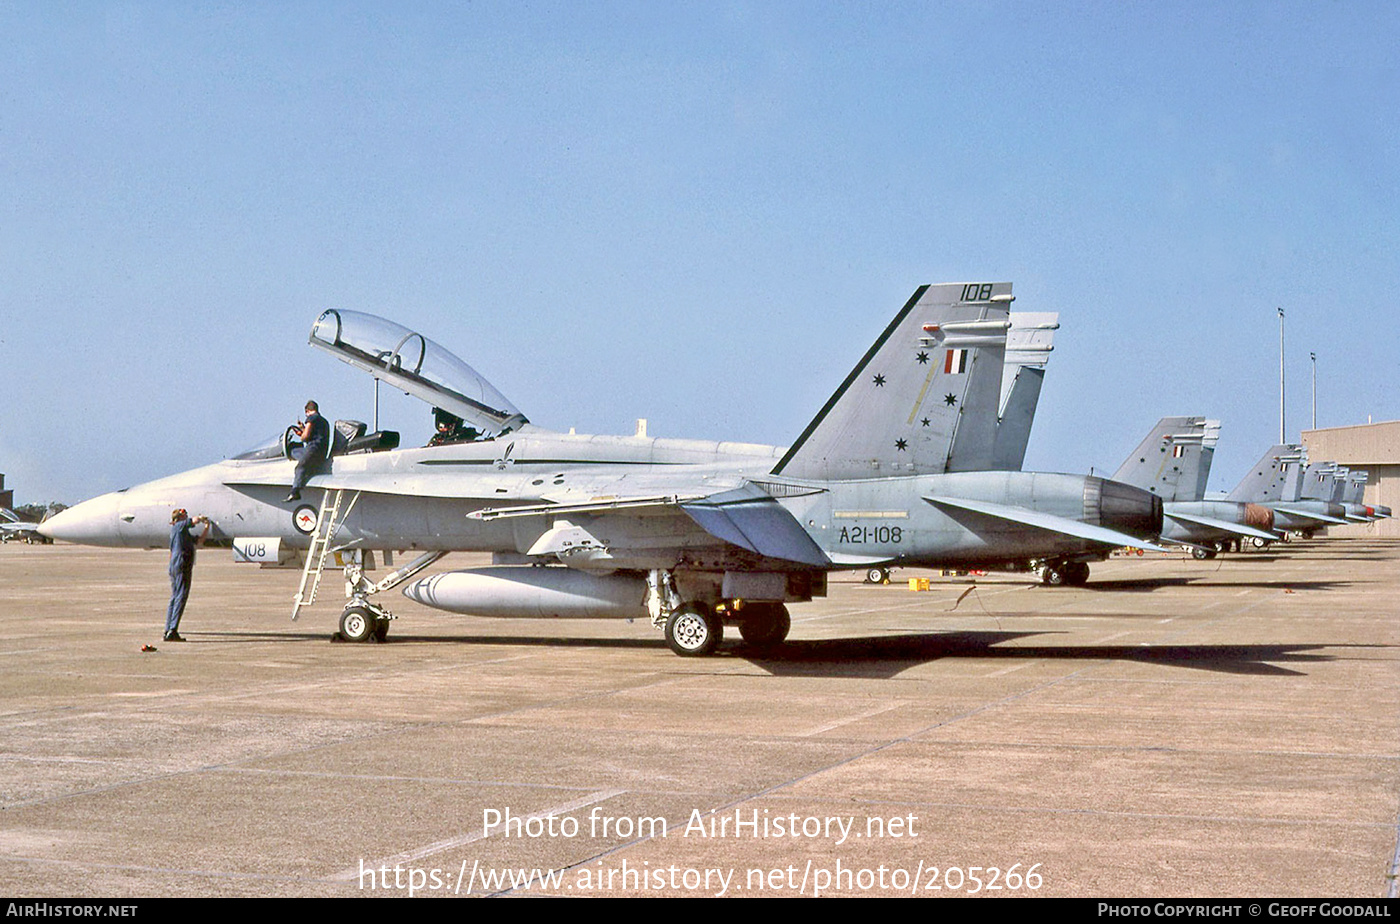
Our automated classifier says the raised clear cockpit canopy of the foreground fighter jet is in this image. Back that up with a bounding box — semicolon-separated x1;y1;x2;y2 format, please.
311;308;526;435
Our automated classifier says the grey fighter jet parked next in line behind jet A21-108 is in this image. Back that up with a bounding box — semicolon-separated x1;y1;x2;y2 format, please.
1113;417;1278;559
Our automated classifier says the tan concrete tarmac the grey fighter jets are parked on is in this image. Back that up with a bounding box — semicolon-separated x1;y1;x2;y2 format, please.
0;539;1400;897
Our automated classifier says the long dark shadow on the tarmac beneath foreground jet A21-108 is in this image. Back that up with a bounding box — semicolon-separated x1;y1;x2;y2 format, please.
192;631;1349;679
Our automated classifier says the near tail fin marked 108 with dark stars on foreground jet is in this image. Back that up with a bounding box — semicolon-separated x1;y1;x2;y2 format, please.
773;283;1012;480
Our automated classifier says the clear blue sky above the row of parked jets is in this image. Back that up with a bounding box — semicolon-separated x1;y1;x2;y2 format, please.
0;0;1400;503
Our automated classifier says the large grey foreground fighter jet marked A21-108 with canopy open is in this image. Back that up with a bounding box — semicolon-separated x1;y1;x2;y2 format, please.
43;283;1162;655
